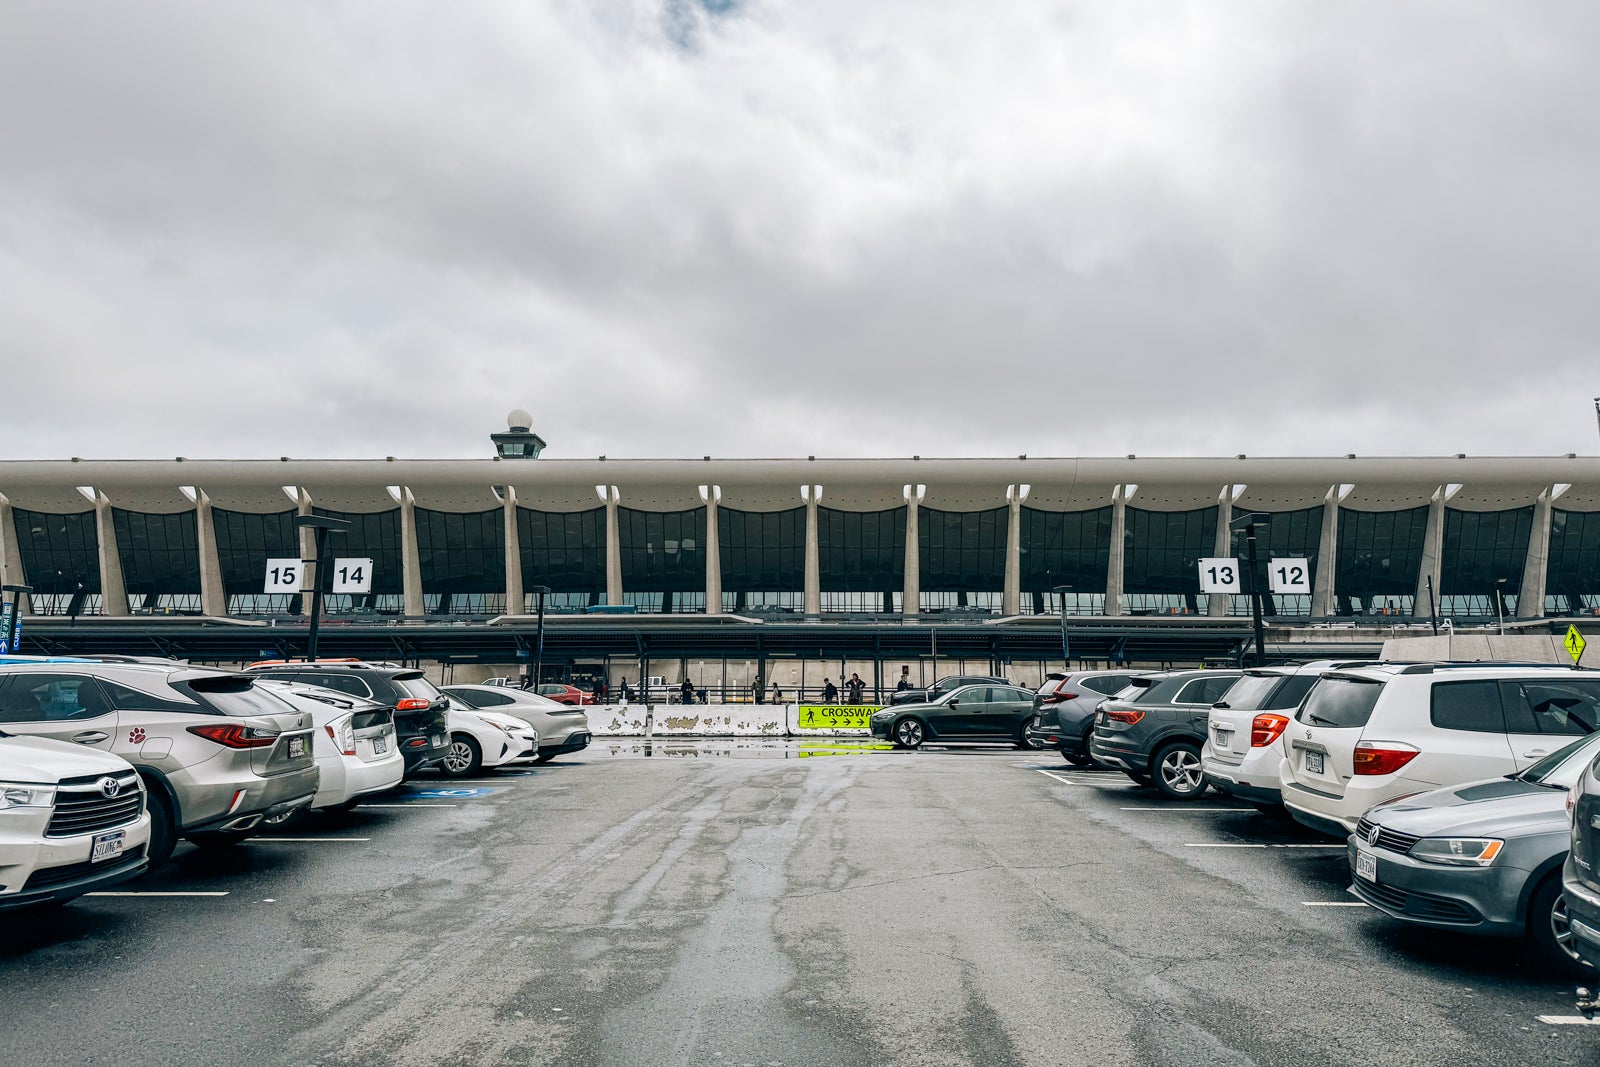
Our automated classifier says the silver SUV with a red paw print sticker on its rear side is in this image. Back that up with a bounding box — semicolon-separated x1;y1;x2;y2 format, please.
0;661;318;865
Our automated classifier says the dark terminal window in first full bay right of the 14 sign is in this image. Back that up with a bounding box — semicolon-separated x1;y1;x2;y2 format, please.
416;507;506;614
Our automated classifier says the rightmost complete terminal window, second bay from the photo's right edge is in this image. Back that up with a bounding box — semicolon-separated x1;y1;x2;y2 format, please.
1438;504;1533;616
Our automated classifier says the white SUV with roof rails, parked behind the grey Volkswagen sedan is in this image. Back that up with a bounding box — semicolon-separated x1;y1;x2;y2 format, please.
1278;664;1600;837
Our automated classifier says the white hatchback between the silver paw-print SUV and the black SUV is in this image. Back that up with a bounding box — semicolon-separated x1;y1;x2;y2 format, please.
256;678;405;824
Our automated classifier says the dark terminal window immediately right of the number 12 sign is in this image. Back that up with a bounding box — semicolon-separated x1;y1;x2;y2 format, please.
1334;504;1427;614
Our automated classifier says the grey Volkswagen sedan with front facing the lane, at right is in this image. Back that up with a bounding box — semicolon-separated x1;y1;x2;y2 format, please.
1349;733;1600;969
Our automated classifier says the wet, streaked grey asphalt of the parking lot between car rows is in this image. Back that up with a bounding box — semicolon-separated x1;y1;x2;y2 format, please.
0;741;1600;1067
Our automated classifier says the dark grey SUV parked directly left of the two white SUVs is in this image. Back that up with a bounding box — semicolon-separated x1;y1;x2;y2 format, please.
1090;670;1242;800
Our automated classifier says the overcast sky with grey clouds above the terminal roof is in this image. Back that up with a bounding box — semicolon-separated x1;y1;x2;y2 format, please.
0;0;1600;458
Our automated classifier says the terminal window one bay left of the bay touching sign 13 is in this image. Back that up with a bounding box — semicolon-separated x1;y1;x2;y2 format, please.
1018;506;1110;614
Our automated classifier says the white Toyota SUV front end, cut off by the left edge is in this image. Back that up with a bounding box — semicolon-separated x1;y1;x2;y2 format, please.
0;734;150;910
